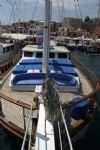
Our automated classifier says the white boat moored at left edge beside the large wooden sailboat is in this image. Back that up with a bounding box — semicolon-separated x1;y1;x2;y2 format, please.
0;40;20;79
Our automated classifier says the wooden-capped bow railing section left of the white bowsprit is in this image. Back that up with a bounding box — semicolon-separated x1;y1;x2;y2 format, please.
0;93;31;138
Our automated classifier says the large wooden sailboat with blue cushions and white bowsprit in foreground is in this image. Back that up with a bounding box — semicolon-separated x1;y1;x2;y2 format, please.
0;0;100;150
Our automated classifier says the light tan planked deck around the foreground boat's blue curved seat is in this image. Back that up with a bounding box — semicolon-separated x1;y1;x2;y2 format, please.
1;71;92;137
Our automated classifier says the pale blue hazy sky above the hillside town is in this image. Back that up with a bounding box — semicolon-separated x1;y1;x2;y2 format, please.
0;0;99;24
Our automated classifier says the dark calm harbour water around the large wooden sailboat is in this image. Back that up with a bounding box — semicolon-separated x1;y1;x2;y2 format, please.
0;52;100;150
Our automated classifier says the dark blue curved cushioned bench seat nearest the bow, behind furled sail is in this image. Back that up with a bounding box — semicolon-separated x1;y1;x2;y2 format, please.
12;73;77;86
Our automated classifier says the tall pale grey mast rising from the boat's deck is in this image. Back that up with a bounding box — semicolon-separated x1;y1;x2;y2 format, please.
42;0;51;73
